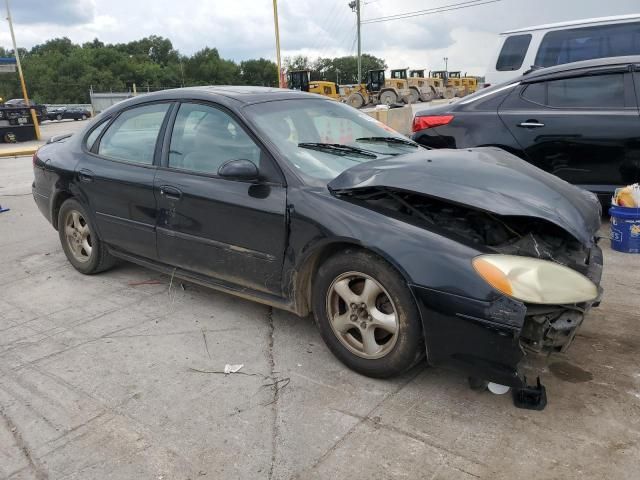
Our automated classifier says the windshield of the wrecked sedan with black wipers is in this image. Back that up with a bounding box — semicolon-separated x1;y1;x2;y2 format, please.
246;99;419;185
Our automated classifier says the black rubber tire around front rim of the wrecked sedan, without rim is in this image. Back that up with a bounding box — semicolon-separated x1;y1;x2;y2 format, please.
312;248;425;378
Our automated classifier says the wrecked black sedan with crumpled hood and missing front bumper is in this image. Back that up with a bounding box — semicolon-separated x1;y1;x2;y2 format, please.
33;87;602;407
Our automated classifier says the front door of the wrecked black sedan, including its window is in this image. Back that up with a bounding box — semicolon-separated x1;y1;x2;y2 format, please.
154;103;286;295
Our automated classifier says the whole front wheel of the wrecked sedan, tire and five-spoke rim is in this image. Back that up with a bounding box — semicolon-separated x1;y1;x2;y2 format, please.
312;249;425;378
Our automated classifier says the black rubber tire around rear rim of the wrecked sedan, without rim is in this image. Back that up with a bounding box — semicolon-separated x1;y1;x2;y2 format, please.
58;198;116;275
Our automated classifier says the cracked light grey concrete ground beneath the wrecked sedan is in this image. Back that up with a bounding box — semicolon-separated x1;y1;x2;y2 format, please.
0;122;640;480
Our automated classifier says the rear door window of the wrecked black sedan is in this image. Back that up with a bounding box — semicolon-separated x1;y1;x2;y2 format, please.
98;103;169;165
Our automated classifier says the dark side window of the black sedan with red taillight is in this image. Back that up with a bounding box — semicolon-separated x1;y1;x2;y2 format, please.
547;74;624;108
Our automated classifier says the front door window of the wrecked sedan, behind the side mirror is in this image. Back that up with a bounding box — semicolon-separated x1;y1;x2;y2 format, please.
169;103;261;175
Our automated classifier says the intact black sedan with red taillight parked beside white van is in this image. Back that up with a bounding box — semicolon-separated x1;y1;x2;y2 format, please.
413;56;640;205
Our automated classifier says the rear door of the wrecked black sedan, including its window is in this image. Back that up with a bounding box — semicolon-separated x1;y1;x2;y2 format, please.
76;103;172;258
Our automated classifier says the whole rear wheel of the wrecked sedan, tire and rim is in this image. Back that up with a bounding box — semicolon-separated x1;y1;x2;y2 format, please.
58;198;115;275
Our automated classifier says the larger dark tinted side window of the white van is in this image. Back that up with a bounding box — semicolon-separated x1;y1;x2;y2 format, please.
535;22;640;67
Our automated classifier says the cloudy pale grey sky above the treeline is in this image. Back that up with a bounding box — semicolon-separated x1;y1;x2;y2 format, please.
0;0;640;74
